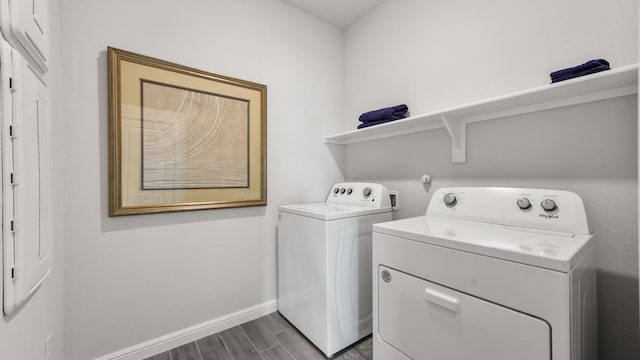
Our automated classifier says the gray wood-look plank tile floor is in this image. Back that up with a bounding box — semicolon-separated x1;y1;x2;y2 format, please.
145;312;373;360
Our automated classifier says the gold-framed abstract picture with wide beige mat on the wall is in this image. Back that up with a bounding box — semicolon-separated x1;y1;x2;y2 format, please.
107;47;267;216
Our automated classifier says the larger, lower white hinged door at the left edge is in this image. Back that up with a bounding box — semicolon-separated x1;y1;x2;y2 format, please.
0;42;52;314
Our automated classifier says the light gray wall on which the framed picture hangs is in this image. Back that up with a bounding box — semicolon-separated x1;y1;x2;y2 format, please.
60;0;343;360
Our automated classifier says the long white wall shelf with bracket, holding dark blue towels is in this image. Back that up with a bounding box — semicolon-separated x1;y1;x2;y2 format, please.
325;64;638;163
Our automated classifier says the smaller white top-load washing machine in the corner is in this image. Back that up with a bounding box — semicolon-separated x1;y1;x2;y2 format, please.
278;183;391;357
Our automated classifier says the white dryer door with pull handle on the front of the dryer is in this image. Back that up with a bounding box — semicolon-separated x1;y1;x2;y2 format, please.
377;266;551;360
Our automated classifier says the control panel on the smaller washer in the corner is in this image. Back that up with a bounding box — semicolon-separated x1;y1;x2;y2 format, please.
327;182;391;208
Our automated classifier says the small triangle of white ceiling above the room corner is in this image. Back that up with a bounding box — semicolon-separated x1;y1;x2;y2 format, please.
282;0;384;28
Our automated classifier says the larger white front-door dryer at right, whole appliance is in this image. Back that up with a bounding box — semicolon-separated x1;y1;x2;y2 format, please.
373;188;598;360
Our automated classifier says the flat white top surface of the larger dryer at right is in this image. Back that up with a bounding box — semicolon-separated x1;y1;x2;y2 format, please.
373;216;592;272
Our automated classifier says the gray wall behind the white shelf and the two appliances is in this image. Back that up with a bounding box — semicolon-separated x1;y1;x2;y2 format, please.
344;0;640;360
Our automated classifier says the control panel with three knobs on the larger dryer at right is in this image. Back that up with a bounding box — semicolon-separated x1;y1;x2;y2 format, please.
427;187;591;234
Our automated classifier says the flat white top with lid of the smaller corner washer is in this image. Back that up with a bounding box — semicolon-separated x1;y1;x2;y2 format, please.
278;202;391;220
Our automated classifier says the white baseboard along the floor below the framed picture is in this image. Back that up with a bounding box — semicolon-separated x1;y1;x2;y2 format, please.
95;300;278;360
